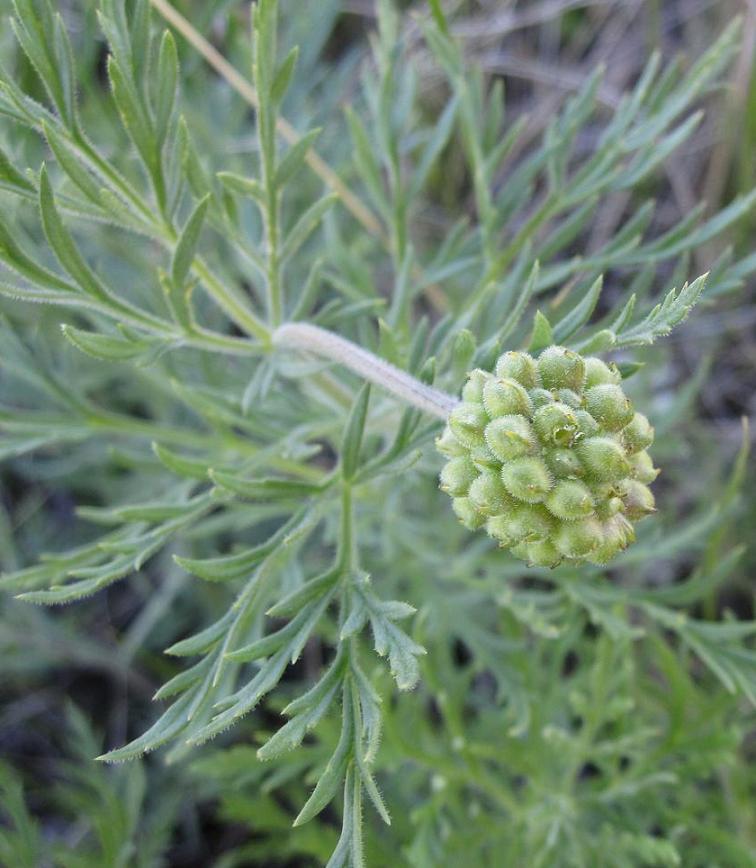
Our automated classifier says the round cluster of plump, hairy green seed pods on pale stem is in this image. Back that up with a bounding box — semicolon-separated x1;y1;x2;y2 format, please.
436;347;659;567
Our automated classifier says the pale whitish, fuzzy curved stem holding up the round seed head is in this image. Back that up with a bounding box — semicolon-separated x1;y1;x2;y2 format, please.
273;323;459;419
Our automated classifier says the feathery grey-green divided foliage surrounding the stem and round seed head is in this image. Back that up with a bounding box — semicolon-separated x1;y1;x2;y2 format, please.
0;0;756;868
